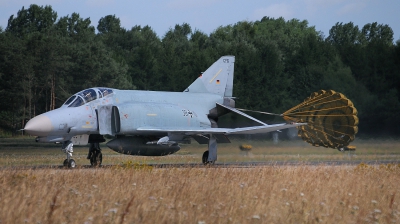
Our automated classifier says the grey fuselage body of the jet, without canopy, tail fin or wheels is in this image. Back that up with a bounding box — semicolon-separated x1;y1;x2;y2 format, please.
25;88;224;142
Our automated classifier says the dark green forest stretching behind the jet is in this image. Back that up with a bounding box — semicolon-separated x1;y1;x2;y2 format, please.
0;4;400;137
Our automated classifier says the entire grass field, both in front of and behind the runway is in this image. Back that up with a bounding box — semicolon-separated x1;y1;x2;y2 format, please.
0;138;400;223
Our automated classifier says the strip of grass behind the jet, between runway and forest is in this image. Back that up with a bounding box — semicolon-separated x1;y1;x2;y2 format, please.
0;138;400;167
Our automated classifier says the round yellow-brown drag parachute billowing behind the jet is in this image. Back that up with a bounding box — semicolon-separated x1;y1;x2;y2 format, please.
282;90;358;149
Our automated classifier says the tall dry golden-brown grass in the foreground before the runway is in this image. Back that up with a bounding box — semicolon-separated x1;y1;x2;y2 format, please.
0;164;400;223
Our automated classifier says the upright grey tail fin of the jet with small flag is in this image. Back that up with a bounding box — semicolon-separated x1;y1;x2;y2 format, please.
184;55;235;97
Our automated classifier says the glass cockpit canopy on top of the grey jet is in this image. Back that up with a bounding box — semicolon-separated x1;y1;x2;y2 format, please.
63;88;113;107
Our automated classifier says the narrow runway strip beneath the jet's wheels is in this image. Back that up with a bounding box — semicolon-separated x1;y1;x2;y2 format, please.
0;160;400;170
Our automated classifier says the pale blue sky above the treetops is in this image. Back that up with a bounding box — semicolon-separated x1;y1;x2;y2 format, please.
0;0;400;41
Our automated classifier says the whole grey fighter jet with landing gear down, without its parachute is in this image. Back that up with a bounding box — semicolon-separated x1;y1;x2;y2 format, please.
24;56;305;168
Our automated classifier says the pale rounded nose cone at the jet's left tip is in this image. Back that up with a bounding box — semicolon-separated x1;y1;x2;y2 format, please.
24;115;53;136
